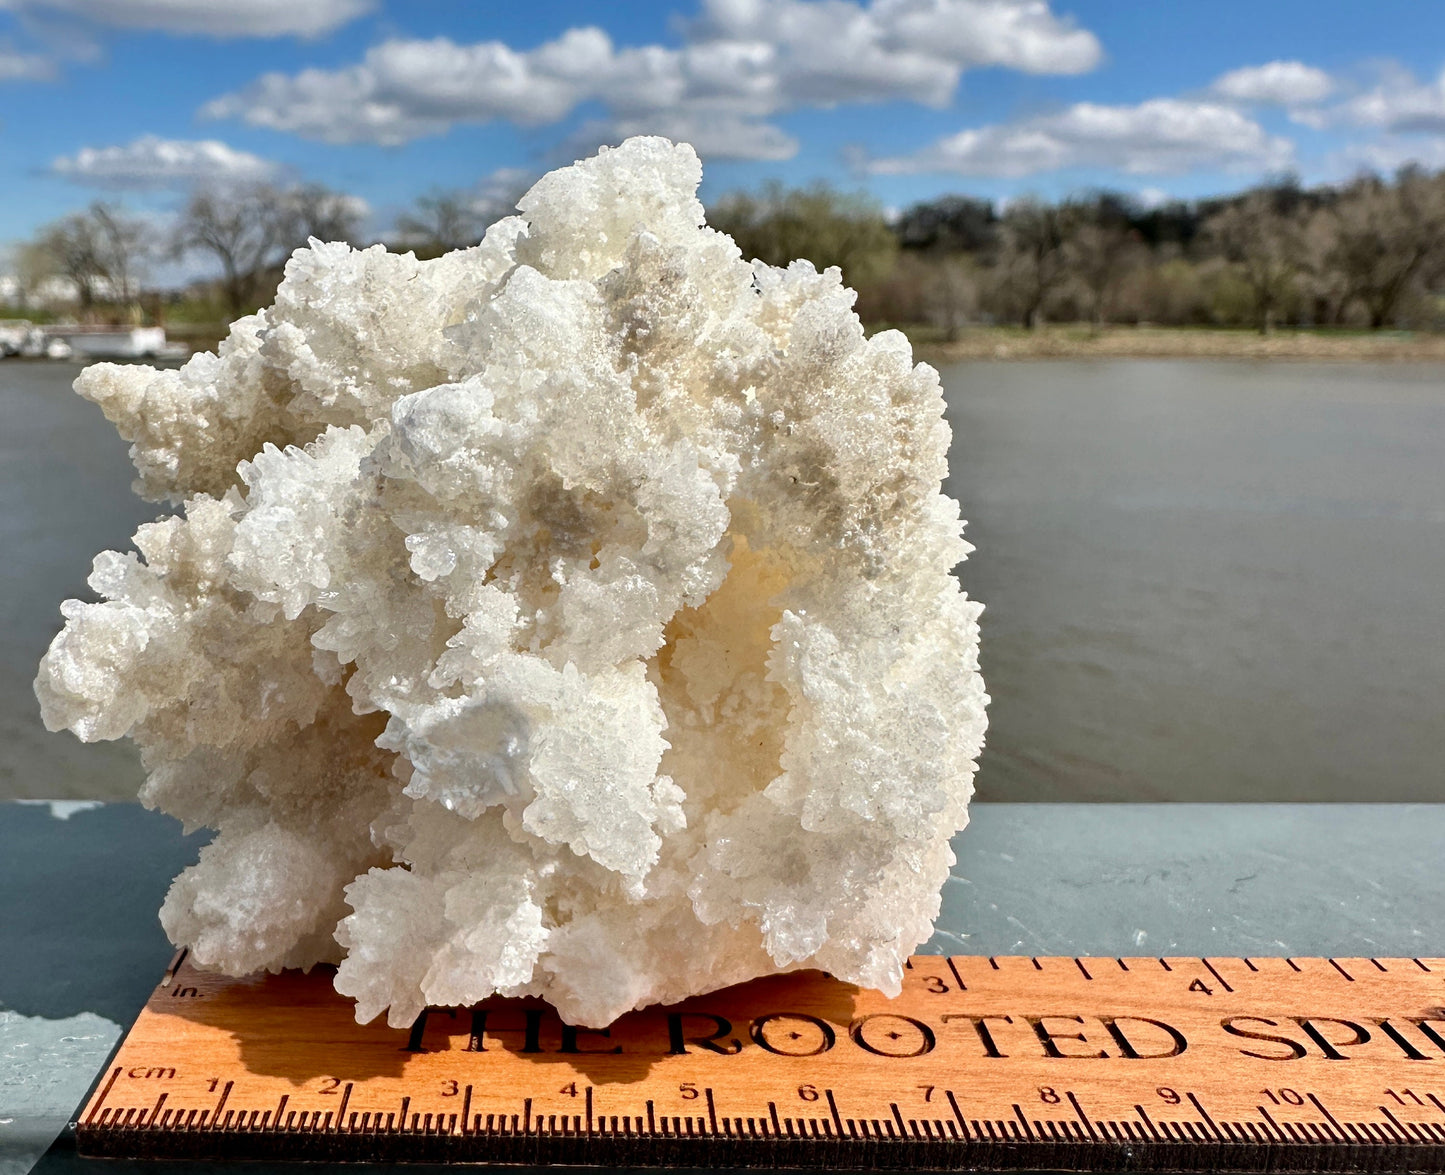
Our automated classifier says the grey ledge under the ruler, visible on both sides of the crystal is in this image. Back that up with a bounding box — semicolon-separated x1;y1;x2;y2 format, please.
0;804;1445;1175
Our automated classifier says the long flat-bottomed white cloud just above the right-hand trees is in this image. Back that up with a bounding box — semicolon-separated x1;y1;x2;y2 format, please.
864;98;1292;178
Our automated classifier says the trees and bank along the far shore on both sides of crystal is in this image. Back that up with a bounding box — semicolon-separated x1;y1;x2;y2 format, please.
8;168;1445;363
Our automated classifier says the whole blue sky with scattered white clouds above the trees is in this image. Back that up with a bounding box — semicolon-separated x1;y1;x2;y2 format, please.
8;0;1445;278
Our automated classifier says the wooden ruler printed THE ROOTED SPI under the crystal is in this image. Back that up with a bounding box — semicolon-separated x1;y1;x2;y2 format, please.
77;955;1445;1171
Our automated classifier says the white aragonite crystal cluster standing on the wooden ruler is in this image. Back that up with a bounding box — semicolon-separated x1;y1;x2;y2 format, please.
36;139;987;1026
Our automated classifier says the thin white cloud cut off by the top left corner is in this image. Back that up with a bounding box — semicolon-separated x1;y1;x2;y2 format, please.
0;0;376;38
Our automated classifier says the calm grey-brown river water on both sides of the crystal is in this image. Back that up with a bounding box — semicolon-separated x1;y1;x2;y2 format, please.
0;360;1445;799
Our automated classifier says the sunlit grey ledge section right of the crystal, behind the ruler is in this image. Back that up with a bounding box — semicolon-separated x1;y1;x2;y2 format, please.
925;804;1445;957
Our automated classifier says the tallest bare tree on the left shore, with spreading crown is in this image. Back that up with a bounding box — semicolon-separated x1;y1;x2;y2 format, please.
176;184;296;317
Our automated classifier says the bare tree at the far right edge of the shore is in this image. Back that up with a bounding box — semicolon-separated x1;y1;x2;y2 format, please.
1327;169;1445;330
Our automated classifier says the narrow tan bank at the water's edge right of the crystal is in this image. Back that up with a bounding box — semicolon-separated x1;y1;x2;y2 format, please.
903;324;1445;366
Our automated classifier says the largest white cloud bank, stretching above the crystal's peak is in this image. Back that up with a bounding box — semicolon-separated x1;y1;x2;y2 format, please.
202;0;1100;159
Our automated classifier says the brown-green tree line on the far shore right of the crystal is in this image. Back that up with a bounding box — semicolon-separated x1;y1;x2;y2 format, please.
708;168;1445;337
